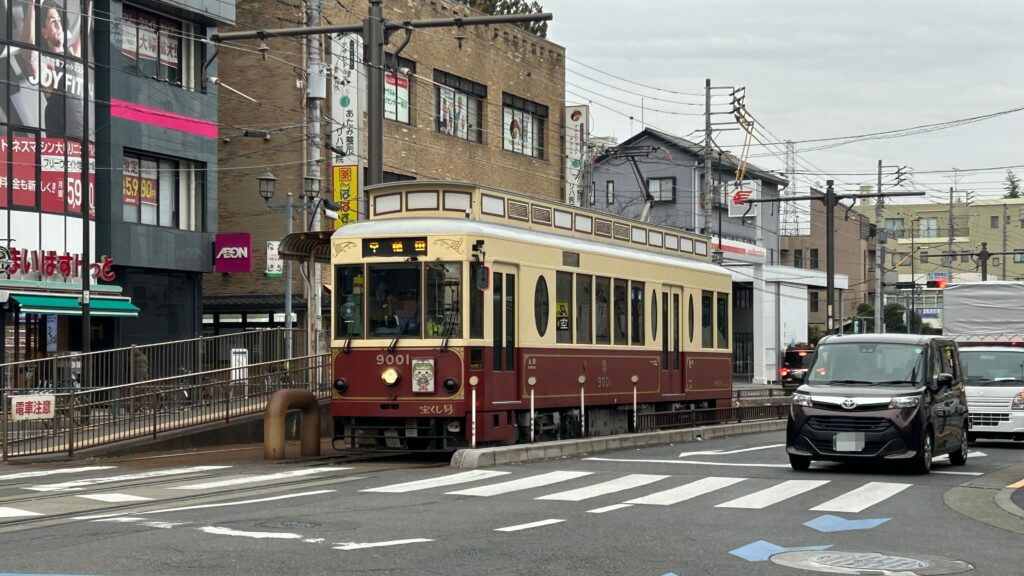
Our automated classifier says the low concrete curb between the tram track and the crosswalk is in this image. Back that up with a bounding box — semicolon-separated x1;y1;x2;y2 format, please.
451;419;786;468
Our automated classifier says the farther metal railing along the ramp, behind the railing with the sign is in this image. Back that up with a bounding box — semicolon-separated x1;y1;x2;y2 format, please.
0;328;306;392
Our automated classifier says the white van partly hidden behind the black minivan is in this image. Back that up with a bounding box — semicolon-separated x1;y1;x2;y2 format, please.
959;344;1024;441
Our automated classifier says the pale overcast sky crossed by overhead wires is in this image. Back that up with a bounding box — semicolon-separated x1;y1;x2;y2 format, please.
540;0;1024;199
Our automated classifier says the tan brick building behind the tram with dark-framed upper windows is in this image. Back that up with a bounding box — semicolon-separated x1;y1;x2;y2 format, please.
204;0;565;333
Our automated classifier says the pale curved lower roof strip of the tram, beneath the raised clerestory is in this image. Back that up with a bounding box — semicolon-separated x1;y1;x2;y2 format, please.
333;217;731;276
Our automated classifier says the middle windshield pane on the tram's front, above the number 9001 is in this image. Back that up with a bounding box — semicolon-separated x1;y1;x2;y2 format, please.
367;262;422;338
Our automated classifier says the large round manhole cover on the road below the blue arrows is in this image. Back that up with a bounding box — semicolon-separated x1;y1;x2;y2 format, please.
771;550;974;576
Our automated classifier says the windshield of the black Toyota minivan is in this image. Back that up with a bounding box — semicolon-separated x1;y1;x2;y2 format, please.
807;342;925;386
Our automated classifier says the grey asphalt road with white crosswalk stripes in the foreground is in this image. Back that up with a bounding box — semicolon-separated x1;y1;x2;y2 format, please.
0;433;1024;576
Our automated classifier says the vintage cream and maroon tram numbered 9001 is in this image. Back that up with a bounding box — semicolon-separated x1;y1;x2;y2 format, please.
330;181;732;451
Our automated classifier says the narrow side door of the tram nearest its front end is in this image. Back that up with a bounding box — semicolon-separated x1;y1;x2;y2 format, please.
489;263;517;402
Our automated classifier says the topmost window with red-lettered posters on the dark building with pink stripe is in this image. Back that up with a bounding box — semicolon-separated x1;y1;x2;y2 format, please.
121;5;206;90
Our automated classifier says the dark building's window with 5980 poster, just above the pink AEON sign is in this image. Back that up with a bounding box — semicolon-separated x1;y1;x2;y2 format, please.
121;152;205;232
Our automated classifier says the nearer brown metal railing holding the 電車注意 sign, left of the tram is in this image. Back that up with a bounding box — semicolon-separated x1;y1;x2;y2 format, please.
0;354;331;460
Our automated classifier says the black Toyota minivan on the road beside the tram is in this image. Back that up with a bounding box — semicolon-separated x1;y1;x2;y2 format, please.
785;334;970;474
